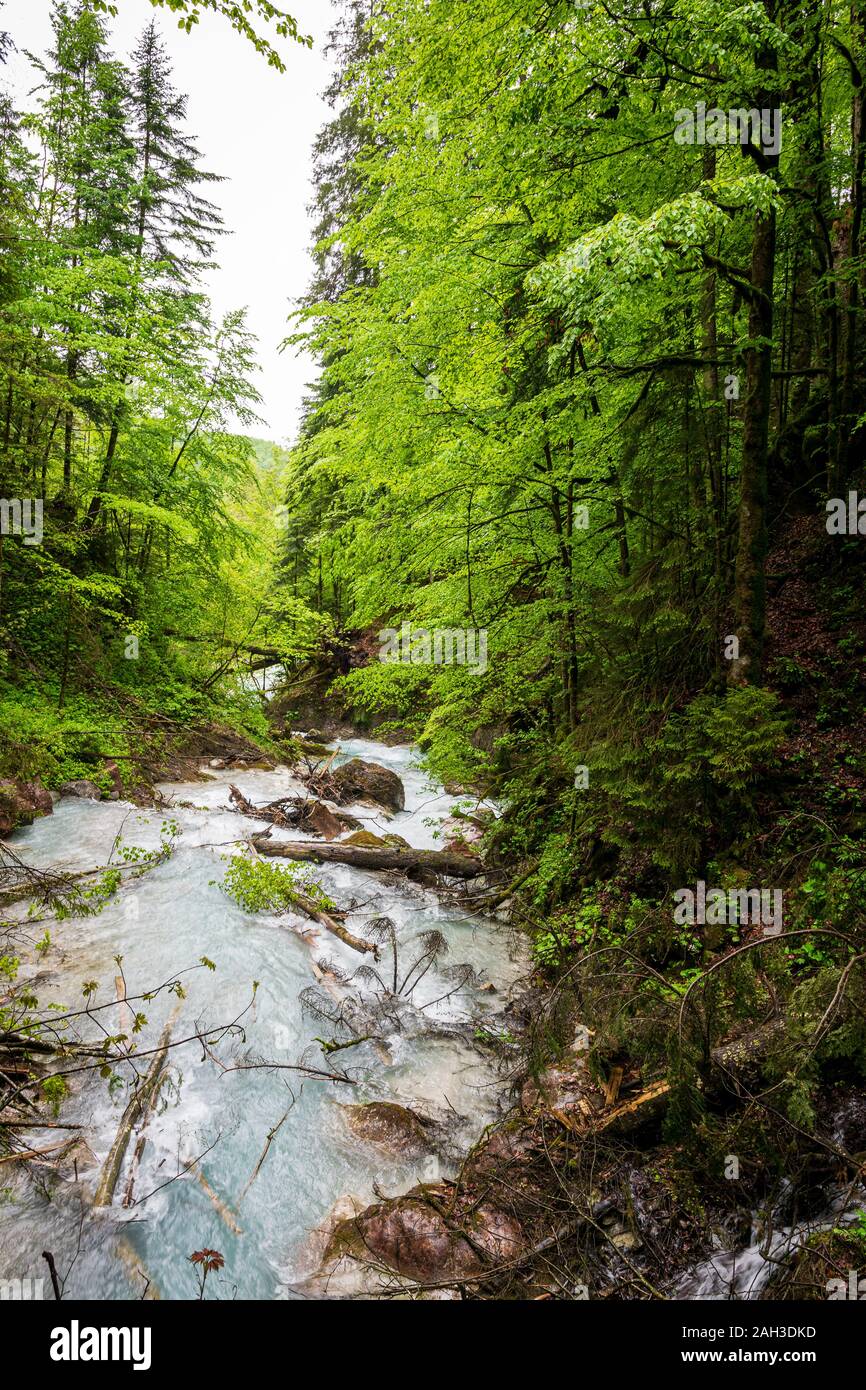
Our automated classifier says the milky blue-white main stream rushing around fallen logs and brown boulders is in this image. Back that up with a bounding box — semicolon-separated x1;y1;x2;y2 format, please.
0;739;521;1298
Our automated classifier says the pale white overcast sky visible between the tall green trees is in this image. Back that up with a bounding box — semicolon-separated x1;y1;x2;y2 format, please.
0;0;335;442
